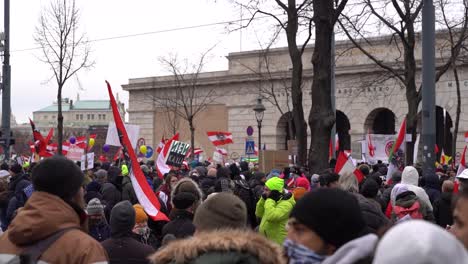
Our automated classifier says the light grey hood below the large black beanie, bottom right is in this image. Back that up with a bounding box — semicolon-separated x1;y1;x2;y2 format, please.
322;234;379;264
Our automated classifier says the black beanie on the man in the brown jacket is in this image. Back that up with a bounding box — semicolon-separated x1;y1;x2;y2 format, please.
32;156;84;201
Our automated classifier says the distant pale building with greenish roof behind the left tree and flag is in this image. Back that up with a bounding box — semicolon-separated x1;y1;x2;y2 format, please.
33;96;125;128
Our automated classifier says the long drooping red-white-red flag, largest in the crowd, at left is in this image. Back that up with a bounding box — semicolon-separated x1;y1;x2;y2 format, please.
106;81;169;221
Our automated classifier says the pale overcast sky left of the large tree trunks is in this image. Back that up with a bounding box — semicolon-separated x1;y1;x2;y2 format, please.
0;0;286;123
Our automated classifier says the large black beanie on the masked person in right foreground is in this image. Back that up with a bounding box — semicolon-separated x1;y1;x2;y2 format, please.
290;188;367;248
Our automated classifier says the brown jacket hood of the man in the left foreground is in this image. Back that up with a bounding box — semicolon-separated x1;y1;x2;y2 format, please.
8;192;80;246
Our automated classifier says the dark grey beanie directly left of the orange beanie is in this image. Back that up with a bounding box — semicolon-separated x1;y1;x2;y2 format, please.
110;200;135;237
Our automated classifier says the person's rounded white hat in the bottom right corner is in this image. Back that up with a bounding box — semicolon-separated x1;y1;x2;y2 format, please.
373;220;468;264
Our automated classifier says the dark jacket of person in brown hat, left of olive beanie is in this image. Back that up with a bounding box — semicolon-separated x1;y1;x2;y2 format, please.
162;209;195;238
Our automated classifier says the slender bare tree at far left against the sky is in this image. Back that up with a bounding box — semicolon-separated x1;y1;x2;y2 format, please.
34;0;93;155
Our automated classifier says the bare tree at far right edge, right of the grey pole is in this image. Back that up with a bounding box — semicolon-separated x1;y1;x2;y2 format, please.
436;0;468;157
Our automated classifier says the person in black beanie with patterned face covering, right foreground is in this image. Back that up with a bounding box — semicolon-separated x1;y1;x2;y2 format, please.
284;188;377;264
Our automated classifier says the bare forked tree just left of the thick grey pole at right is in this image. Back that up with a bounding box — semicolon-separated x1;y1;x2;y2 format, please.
338;0;466;164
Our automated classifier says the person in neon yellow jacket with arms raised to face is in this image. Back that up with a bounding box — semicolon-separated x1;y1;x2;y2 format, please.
255;177;296;245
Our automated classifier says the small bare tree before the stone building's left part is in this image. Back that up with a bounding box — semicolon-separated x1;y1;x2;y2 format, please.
146;49;218;158
